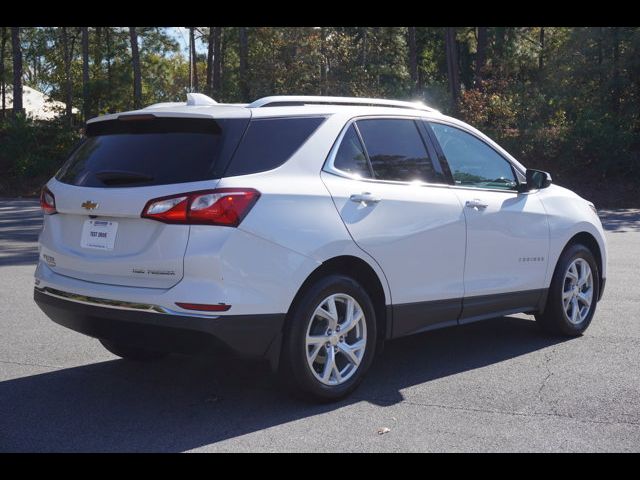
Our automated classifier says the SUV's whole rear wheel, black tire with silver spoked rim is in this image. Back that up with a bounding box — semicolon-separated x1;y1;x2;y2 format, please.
280;275;376;401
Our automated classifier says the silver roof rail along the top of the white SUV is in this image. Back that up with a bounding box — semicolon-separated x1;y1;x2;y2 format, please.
248;95;439;113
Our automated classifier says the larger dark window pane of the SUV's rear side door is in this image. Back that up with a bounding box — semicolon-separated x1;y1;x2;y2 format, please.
357;118;436;182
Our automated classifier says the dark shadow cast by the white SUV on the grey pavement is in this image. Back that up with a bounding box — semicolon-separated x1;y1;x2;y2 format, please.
0;317;562;452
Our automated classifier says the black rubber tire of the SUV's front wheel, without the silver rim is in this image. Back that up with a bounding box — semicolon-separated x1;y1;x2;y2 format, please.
536;243;600;337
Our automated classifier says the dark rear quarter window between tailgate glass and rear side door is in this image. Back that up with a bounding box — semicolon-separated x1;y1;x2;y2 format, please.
225;117;324;177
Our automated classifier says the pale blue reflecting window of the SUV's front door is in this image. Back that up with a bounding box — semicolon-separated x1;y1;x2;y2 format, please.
430;123;517;190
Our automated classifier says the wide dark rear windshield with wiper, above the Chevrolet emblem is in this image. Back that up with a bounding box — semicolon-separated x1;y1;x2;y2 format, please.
56;118;248;187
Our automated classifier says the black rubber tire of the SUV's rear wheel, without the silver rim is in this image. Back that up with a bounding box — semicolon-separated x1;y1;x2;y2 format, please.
279;274;377;402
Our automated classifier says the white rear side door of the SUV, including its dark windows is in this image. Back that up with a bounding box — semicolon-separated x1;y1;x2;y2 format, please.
322;118;465;336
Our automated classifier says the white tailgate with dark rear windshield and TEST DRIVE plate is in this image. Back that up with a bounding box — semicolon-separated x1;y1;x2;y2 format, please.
40;114;249;288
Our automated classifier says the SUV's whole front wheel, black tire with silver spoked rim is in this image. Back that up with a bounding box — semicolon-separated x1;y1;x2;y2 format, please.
536;244;600;336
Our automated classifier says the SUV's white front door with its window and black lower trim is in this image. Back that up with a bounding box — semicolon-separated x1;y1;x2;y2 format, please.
431;122;549;322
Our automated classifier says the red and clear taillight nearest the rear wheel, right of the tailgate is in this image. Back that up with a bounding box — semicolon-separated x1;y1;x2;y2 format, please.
141;188;260;227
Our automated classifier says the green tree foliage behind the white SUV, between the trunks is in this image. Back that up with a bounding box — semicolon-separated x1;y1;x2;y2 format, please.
0;27;640;202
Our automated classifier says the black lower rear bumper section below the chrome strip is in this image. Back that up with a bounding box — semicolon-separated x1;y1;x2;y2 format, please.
34;287;285;358
